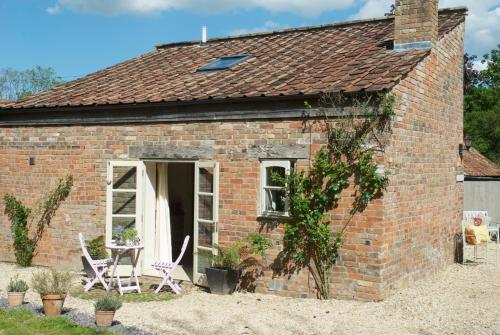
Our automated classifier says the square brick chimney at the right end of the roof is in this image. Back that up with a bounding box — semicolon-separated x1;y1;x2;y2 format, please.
394;0;438;51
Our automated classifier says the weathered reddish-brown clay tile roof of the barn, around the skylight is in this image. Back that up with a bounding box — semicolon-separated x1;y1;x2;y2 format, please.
4;8;466;108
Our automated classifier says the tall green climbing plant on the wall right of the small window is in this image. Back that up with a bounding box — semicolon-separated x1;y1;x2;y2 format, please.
273;94;395;299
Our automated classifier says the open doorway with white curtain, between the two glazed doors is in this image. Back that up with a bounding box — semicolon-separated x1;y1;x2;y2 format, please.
142;162;195;281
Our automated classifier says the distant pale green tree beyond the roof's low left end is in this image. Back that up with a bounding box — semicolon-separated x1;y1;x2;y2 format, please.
0;66;63;100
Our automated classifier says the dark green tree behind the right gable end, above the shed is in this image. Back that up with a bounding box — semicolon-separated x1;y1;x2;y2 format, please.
464;45;500;164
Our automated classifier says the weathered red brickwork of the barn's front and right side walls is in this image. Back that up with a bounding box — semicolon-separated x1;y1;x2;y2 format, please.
0;25;463;300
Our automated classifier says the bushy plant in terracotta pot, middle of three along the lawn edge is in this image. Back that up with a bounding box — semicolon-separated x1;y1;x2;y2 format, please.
31;269;72;316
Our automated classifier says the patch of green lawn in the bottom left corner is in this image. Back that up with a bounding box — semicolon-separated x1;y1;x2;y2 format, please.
0;309;115;335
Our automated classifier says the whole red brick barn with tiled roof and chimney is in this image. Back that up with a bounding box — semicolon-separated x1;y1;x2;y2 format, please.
0;0;467;300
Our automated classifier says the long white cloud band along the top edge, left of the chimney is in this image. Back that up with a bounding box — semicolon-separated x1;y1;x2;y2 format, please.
59;0;359;17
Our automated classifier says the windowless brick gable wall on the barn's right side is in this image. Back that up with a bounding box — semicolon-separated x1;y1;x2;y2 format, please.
380;21;464;292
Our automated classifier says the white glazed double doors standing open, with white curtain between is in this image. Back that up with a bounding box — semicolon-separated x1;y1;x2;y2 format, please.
106;161;219;285
